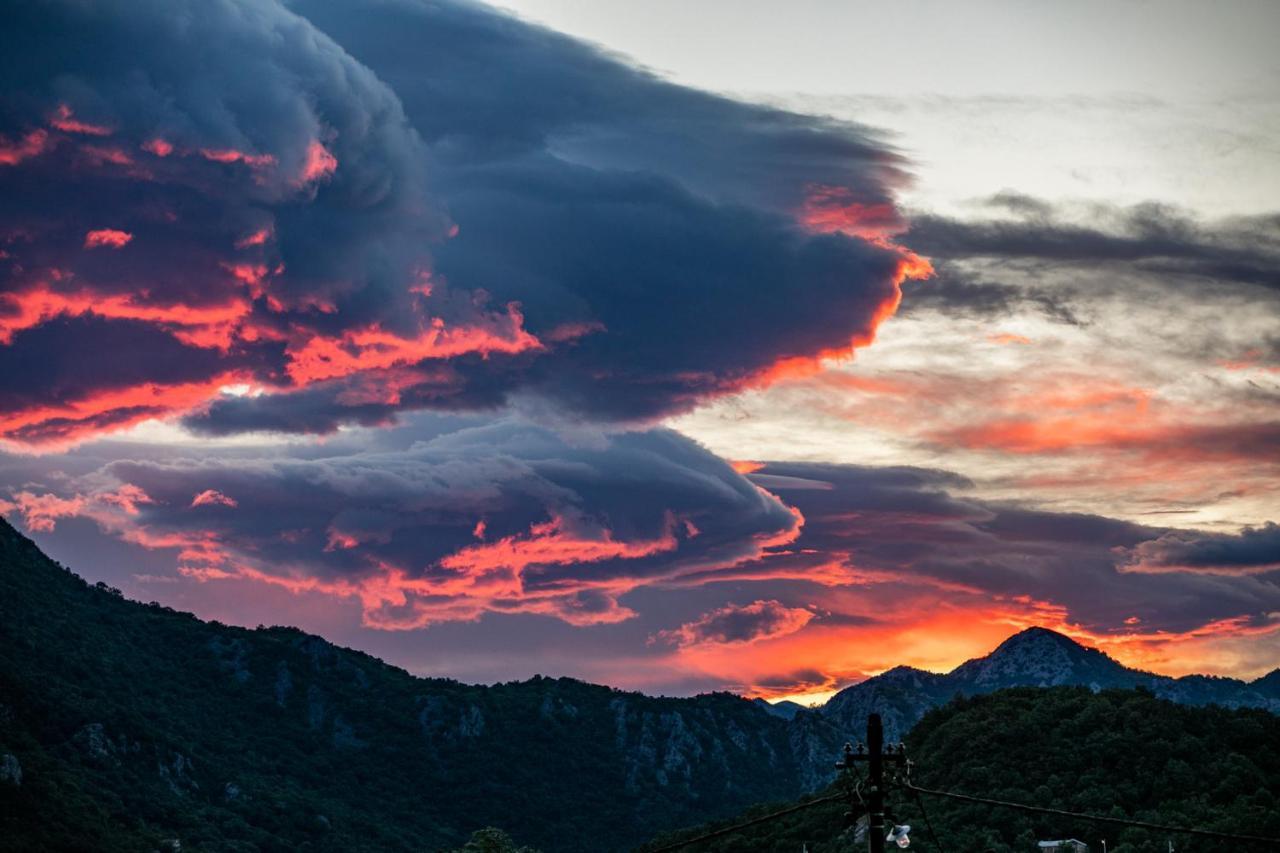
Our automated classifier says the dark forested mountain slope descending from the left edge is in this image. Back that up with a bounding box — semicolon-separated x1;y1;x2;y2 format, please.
0;521;841;853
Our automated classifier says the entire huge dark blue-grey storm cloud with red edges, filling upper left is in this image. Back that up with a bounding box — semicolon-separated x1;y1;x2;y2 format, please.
0;0;908;443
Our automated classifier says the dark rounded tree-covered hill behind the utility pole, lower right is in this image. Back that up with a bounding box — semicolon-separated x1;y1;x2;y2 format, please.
643;686;1280;853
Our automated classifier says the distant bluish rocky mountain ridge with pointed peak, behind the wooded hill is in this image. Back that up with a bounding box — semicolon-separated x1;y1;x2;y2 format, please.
820;628;1280;739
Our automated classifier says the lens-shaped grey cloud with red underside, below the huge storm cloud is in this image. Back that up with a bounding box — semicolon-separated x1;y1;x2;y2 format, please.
6;420;799;628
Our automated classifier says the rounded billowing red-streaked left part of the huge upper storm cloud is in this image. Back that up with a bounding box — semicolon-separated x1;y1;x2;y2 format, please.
0;3;465;443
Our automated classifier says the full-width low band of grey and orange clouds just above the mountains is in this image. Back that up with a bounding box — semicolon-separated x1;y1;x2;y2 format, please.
0;427;1280;695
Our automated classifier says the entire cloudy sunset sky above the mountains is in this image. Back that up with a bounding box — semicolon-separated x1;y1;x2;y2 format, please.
0;0;1280;699
